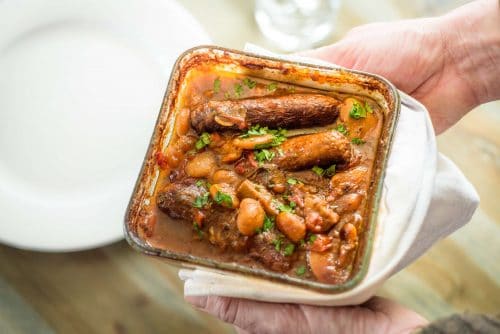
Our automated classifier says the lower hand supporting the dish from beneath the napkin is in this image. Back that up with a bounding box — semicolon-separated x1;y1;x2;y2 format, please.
185;296;427;334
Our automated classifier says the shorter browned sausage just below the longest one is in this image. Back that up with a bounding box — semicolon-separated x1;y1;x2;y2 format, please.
271;131;352;170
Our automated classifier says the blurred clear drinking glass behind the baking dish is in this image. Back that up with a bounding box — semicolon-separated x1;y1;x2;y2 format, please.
255;0;340;51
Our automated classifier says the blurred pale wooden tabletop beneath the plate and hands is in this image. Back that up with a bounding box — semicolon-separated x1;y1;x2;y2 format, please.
0;0;500;333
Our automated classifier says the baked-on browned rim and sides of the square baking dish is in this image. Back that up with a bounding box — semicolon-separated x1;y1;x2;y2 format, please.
125;46;399;292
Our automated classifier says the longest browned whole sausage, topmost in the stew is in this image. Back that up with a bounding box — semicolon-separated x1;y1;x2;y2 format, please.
191;94;340;133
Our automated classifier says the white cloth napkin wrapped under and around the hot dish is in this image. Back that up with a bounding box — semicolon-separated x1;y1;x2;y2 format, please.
179;44;479;306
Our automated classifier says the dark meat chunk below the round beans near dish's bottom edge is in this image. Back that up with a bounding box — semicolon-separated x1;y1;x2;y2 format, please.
249;230;296;272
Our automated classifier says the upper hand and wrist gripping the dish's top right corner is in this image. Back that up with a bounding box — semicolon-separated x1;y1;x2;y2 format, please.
302;0;500;134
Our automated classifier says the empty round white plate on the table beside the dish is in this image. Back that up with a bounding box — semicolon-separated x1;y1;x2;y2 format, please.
0;0;209;251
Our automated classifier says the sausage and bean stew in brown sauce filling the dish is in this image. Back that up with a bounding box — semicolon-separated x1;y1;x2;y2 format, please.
147;67;383;284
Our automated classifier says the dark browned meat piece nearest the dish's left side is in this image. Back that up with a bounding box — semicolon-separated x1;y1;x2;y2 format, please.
157;179;206;221
